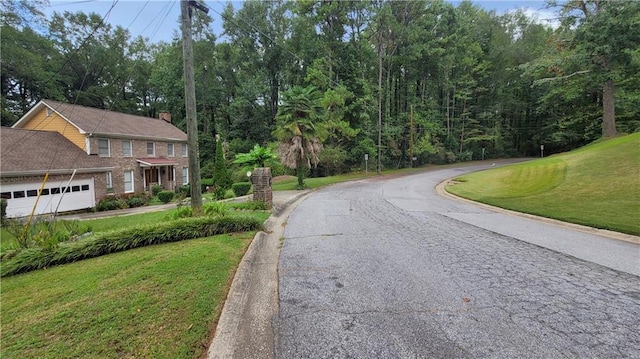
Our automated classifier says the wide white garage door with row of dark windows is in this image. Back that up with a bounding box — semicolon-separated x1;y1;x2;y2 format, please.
0;178;96;218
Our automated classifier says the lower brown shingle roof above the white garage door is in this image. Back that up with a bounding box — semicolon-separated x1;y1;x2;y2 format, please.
0;127;112;177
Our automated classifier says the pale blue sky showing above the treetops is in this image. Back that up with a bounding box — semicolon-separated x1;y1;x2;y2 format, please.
42;0;552;43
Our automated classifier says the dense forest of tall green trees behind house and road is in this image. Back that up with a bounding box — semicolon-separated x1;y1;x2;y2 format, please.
0;0;640;176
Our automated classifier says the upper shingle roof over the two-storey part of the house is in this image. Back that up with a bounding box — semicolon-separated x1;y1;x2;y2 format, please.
42;100;187;142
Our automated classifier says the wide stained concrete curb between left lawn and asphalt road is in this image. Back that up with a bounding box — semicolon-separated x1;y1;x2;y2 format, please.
206;191;313;359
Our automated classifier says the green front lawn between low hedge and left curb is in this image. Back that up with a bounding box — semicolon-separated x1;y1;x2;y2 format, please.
0;233;254;359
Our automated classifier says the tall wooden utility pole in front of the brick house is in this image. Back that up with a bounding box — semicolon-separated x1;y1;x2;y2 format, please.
180;0;207;216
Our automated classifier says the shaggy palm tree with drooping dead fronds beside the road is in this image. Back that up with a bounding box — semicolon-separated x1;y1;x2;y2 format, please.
273;86;327;189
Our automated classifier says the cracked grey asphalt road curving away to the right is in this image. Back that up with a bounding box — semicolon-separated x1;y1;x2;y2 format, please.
274;165;640;358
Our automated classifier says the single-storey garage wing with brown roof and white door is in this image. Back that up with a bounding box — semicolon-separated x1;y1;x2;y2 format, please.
0;127;113;217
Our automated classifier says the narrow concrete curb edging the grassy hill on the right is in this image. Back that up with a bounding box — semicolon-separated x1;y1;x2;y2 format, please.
436;180;640;244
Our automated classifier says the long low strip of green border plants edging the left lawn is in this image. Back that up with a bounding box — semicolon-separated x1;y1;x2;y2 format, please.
0;215;263;277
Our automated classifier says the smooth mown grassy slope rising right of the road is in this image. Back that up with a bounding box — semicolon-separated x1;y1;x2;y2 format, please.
447;133;640;235
